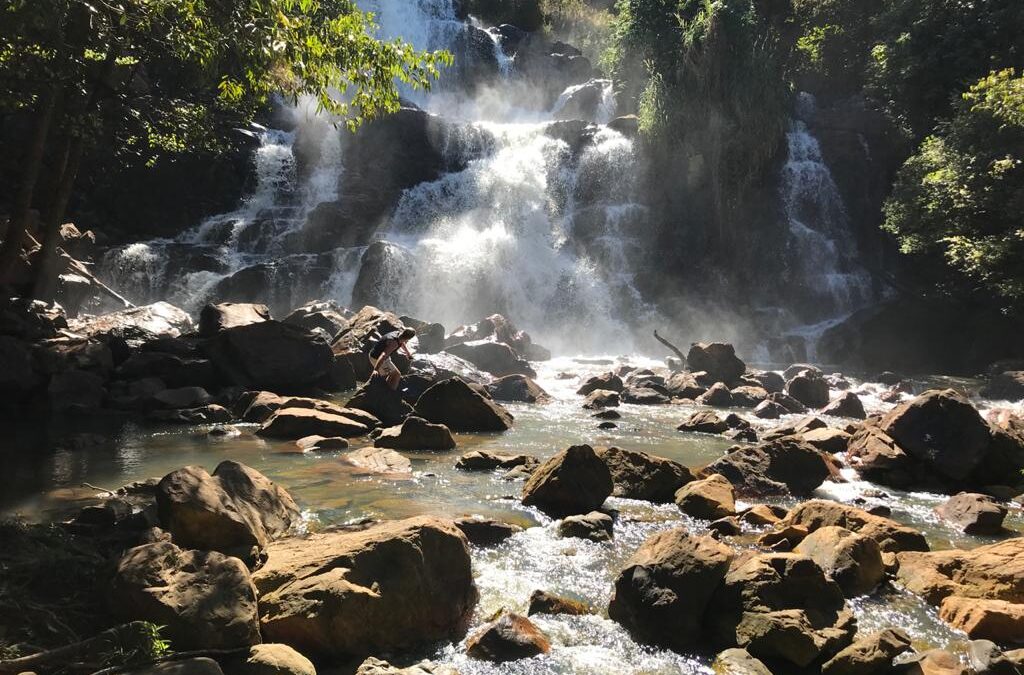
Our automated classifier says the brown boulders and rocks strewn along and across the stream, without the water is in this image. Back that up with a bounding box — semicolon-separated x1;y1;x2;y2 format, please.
0;301;1024;675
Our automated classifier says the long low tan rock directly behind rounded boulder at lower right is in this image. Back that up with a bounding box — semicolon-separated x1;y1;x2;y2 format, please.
782;499;928;553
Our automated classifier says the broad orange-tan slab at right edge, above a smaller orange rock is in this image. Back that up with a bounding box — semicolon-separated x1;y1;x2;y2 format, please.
896;538;1024;605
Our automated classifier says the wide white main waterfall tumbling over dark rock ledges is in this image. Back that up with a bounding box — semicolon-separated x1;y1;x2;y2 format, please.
103;0;650;351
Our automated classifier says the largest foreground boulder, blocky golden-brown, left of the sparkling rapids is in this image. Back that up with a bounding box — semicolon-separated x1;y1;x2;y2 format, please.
253;516;477;660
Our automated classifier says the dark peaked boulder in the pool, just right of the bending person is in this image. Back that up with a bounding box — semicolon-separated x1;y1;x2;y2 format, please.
416;377;513;431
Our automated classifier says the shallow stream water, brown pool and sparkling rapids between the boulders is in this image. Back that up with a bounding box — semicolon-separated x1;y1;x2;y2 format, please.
0;358;1024;675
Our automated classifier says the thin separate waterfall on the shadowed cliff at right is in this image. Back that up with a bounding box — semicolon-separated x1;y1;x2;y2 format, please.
780;93;876;360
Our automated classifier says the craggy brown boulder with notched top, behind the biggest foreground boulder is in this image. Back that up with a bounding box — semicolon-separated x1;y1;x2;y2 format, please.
157;460;299;559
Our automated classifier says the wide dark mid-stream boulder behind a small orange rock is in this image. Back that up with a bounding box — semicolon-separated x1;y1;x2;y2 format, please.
701;438;831;497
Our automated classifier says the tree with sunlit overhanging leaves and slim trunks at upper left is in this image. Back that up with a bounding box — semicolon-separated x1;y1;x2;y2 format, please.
0;0;451;299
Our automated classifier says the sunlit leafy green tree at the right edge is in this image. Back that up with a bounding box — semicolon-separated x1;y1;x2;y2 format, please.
884;69;1024;308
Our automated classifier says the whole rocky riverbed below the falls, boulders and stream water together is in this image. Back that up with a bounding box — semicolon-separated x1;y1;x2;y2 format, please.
0;303;1024;675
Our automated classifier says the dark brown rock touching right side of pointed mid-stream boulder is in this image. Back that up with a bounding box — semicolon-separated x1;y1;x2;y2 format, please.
596;448;693;504
